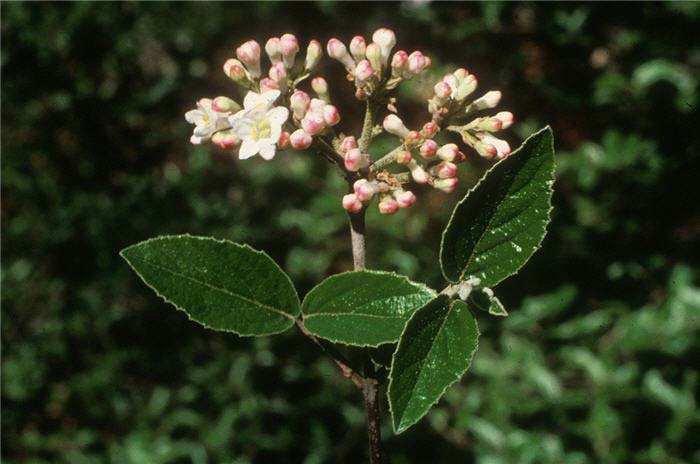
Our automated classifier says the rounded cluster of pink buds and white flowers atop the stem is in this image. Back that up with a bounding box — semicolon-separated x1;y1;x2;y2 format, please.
185;28;513;214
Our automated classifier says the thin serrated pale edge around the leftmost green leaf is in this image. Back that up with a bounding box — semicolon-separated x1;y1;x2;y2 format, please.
119;234;301;337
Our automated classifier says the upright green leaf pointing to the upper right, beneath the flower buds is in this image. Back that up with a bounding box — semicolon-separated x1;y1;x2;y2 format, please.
440;127;554;287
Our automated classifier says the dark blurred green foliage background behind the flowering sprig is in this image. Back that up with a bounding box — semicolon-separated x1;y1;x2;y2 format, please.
1;1;700;464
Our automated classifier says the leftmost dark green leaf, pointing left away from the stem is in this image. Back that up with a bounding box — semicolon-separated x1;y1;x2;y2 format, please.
121;235;300;336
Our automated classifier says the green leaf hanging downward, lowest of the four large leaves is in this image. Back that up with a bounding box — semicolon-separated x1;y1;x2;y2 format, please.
388;295;479;433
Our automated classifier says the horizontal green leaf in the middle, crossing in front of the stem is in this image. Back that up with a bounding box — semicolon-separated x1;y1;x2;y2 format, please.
301;270;435;346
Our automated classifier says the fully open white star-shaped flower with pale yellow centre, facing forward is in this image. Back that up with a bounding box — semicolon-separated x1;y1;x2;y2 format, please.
229;90;289;160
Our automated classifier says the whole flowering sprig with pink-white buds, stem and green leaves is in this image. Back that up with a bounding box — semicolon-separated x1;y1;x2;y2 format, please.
122;29;554;462
